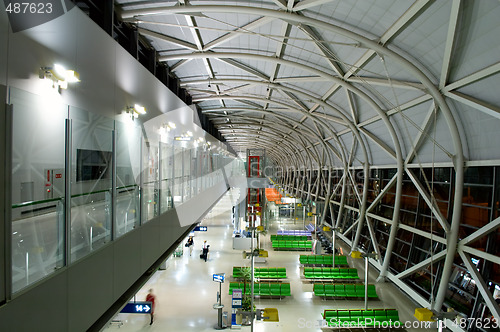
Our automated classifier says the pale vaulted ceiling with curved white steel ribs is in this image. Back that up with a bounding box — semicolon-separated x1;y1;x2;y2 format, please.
116;0;500;167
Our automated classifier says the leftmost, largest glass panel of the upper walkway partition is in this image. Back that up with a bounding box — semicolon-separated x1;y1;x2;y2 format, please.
9;88;67;293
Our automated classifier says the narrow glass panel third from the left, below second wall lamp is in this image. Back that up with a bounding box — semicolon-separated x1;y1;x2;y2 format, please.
115;121;141;237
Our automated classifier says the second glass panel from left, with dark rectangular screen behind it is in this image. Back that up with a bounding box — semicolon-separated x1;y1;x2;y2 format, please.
70;108;114;262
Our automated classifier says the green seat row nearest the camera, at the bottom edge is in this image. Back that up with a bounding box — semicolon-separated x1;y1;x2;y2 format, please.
322;309;401;328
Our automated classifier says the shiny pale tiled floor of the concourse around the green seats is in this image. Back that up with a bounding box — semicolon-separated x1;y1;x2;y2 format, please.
104;191;436;332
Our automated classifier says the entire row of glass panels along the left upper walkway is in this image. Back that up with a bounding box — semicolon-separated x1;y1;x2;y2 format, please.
8;88;234;293
